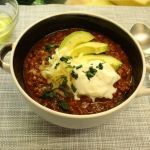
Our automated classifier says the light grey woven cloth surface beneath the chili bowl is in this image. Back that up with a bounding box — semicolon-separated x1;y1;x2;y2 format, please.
0;5;150;150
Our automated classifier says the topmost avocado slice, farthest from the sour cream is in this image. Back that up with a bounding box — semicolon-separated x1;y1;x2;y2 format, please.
59;31;94;50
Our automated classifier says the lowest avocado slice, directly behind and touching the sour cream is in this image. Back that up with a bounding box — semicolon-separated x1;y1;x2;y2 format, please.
77;54;122;70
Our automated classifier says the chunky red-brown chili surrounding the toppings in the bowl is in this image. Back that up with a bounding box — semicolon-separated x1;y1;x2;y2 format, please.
23;28;133;115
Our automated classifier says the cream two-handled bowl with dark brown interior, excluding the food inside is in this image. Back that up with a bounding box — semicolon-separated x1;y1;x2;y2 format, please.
0;12;150;129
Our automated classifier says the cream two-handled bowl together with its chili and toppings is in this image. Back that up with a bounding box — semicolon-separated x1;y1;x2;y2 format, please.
0;12;150;129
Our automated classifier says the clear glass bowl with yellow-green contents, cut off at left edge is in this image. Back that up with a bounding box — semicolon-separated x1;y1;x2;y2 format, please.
0;0;19;46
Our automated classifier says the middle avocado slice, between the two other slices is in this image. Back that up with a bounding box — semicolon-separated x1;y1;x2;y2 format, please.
70;42;108;57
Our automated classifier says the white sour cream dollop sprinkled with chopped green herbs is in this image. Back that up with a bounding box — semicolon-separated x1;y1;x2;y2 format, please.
73;60;120;101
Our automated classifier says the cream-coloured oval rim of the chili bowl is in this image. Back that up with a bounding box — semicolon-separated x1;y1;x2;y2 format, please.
10;11;146;119
